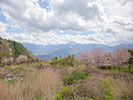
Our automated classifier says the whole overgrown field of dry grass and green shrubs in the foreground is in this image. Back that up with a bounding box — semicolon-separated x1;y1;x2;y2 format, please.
0;61;133;100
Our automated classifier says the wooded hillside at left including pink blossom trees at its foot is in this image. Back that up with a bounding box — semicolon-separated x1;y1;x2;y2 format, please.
0;38;34;66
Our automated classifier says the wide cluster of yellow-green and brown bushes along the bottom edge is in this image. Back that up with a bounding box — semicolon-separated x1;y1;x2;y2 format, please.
55;78;113;100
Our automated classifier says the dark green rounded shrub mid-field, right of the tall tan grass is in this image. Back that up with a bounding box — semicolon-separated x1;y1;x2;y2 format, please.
62;71;88;85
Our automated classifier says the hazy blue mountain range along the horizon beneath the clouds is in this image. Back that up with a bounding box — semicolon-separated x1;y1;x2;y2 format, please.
23;42;133;59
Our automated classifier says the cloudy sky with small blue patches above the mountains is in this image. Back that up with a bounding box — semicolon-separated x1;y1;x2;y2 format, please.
0;0;133;45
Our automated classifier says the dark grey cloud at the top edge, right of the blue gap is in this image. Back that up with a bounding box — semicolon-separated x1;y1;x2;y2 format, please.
50;0;102;20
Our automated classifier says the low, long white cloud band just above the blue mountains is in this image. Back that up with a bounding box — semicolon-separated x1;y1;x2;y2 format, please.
0;20;104;45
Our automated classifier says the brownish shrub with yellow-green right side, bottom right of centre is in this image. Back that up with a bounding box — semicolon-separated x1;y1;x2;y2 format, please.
72;76;113;100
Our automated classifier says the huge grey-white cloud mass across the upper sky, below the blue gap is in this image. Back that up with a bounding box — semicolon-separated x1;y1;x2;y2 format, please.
0;0;105;32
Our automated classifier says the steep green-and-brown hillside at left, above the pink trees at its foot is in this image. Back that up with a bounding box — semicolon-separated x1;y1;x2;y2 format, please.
0;37;33;62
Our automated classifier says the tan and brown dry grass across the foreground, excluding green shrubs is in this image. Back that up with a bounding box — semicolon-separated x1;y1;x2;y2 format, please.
0;64;133;100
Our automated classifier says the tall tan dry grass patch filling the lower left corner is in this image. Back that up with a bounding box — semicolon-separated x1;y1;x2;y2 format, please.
0;68;62;100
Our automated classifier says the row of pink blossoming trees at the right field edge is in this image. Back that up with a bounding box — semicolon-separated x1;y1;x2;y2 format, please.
79;48;133;70
